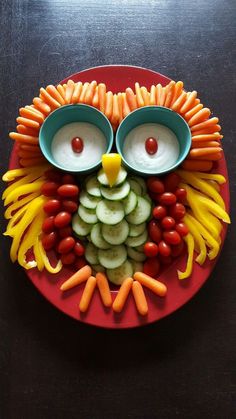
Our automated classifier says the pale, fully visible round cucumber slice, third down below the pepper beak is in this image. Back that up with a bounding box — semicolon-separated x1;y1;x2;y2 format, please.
96;199;125;225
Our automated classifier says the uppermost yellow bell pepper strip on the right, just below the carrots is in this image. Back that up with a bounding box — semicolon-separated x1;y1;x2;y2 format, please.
177;170;225;209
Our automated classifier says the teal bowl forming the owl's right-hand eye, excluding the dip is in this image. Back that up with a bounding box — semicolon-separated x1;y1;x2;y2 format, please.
116;106;191;176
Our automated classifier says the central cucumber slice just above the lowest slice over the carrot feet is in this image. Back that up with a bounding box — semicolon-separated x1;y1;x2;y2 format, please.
98;245;127;269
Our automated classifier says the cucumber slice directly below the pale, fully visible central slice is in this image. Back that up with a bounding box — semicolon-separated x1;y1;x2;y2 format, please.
102;220;129;245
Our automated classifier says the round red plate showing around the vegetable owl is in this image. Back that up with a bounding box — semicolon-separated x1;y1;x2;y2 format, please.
10;65;229;329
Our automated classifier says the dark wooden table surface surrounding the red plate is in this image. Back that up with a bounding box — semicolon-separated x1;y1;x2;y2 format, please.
0;0;236;419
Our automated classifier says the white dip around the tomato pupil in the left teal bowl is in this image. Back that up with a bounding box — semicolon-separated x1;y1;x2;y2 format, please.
51;122;107;170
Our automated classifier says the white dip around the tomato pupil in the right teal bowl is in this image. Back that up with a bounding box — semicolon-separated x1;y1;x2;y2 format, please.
123;123;179;173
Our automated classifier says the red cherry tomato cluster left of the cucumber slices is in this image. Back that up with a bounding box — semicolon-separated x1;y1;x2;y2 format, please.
41;170;86;267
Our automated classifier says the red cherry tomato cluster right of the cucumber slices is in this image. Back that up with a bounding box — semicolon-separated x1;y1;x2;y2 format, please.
143;173;188;277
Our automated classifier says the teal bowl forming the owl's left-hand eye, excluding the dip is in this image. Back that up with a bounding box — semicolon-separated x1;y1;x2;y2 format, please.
39;104;114;174
